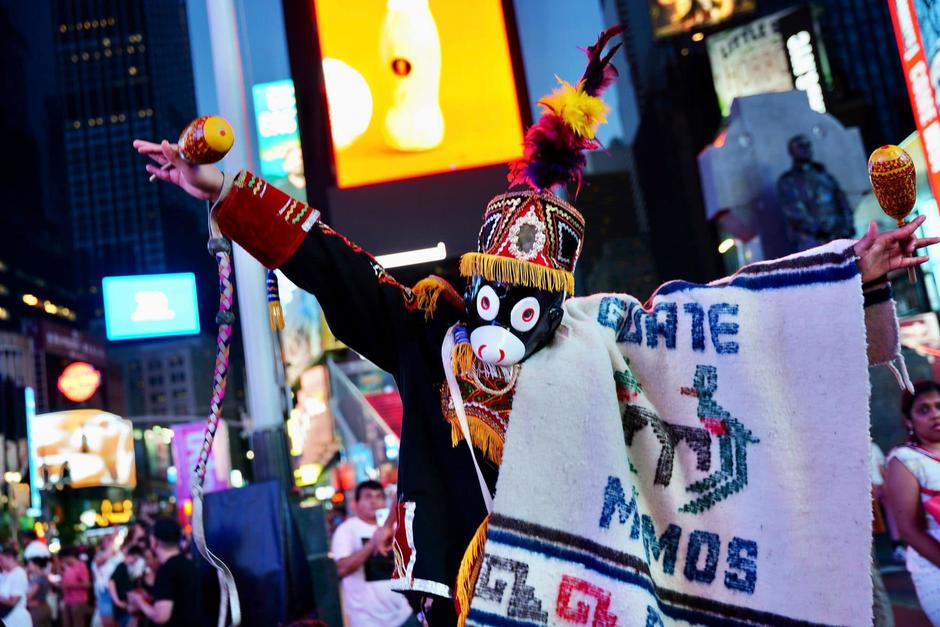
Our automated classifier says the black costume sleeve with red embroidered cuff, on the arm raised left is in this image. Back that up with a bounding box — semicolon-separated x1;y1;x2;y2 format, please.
218;171;463;374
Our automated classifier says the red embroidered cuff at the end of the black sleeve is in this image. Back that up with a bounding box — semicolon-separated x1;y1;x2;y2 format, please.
216;170;320;269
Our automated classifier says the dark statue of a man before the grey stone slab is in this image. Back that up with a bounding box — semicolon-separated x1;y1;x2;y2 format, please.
777;135;855;251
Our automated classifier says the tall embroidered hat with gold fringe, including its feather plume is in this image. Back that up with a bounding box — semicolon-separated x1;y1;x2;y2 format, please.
460;26;623;294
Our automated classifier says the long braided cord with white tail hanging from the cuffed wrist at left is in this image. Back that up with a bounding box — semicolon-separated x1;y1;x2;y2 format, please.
191;237;241;627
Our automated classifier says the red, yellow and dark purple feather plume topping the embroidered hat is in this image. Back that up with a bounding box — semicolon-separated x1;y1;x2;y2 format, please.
509;26;623;190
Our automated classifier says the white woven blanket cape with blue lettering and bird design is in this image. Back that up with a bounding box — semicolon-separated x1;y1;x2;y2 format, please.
468;241;906;627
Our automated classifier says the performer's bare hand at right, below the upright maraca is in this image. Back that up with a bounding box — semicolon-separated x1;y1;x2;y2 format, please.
855;216;940;281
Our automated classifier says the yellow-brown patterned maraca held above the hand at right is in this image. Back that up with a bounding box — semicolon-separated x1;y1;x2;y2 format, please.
868;144;917;283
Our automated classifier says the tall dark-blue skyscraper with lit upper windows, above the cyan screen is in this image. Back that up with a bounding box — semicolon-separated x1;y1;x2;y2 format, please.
54;0;204;317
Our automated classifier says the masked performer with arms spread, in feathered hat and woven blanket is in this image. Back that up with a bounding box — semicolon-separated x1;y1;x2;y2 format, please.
135;31;936;627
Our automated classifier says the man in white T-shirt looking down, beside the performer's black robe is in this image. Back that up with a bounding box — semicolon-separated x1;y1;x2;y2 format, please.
332;481;418;627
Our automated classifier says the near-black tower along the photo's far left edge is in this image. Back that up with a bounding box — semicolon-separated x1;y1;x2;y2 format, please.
0;2;81;331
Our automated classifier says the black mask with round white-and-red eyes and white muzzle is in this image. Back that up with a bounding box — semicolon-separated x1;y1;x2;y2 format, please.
464;276;566;366
